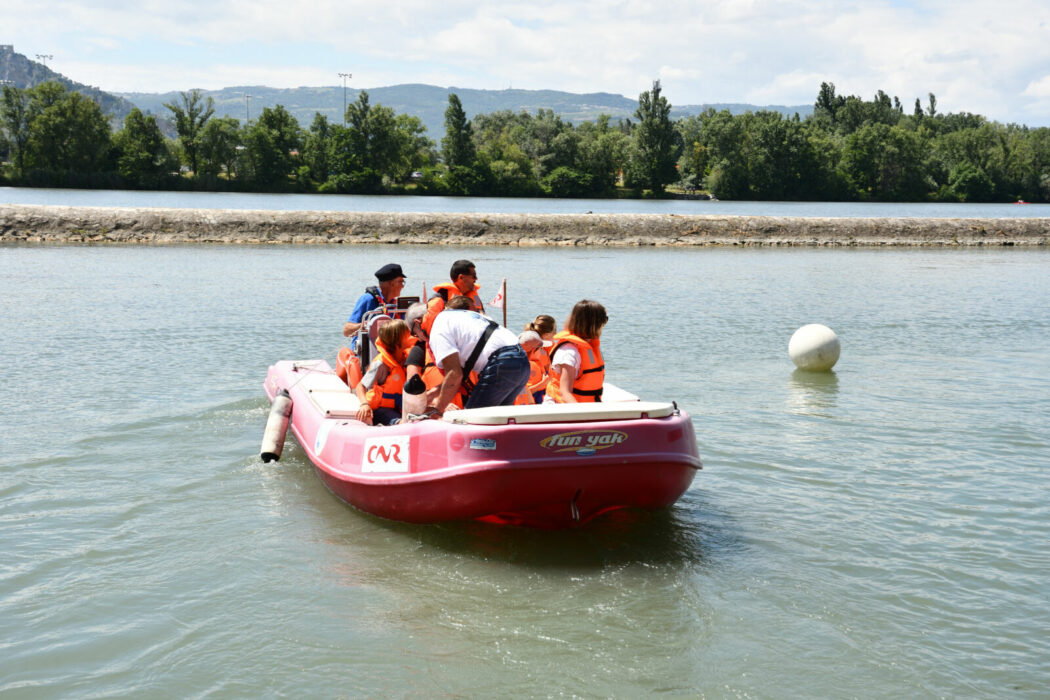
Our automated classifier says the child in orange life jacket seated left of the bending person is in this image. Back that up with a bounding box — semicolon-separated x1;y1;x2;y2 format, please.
354;320;416;425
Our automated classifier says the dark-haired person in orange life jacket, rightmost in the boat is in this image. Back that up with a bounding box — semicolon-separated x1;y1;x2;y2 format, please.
544;299;609;403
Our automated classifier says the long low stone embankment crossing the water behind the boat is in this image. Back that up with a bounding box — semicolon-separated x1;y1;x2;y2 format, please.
0;205;1050;247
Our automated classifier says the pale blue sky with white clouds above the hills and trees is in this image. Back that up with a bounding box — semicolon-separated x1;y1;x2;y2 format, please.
6;0;1050;126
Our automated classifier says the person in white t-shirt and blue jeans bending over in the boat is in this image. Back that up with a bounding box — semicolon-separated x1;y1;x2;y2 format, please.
426;310;529;418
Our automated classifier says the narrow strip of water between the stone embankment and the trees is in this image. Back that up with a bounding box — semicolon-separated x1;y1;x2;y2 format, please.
6;187;1050;218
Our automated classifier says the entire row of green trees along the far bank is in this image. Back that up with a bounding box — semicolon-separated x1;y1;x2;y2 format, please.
0;81;1050;201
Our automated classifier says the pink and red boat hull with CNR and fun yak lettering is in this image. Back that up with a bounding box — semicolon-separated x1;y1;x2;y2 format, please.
265;360;700;528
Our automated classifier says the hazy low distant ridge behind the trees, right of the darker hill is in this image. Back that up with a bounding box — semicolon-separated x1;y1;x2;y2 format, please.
118;84;813;142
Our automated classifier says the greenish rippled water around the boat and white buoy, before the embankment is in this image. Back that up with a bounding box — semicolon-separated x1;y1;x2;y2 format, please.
0;247;1050;700
